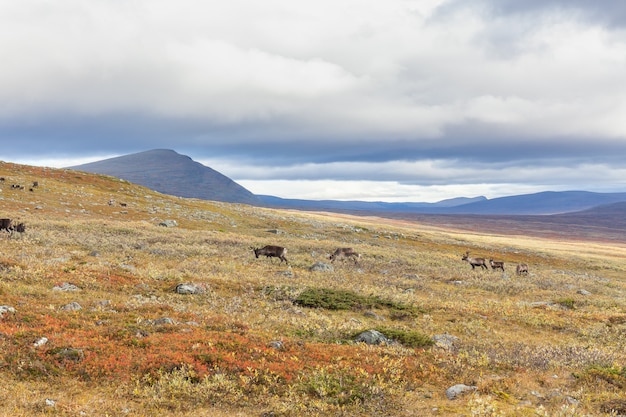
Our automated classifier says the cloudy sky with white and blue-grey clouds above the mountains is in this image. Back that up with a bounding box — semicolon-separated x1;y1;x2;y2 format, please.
0;0;626;202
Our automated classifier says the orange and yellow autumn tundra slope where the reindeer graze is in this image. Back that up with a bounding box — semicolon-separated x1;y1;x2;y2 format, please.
0;163;626;417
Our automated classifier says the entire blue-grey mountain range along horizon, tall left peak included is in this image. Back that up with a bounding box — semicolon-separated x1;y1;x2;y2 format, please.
69;149;626;215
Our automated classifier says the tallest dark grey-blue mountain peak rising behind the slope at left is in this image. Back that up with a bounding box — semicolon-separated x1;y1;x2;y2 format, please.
69;149;262;205
